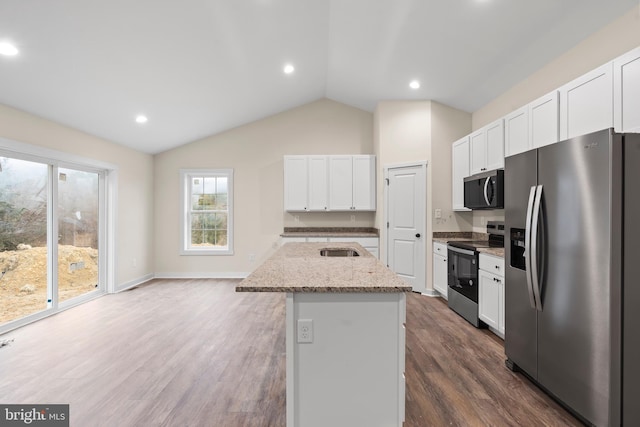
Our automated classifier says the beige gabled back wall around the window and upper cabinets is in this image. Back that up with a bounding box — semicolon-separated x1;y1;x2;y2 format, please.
154;99;374;277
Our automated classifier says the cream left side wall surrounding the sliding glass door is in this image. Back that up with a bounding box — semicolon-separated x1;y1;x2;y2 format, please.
0;105;154;289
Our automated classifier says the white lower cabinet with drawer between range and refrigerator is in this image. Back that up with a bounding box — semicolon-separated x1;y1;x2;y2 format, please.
478;253;504;338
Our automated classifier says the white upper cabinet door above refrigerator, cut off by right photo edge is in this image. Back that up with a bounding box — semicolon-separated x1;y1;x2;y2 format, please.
613;48;640;132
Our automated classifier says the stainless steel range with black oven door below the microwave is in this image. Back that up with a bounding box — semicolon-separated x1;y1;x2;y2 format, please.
447;221;504;328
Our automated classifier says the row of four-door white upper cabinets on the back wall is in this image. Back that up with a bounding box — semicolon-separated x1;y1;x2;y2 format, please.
284;155;376;212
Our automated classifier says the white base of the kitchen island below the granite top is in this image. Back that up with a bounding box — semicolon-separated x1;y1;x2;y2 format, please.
286;292;406;427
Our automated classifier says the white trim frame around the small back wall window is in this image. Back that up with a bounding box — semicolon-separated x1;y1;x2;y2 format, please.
180;169;234;255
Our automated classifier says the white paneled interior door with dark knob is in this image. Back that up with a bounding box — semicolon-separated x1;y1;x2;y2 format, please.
386;164;426;292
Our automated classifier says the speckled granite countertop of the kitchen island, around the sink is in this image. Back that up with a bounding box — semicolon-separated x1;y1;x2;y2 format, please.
236;242;411;293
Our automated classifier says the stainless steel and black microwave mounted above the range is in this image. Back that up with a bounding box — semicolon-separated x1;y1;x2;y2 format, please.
464;169;504;209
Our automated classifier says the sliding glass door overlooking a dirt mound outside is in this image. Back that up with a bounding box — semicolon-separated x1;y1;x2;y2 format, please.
0;156;105;329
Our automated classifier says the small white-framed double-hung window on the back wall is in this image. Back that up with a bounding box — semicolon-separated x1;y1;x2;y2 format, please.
180;169;233;255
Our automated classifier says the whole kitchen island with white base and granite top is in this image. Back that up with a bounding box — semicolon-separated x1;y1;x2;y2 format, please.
236;242;411;427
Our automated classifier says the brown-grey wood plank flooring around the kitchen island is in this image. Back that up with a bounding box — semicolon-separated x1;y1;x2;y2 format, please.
0;280;580;427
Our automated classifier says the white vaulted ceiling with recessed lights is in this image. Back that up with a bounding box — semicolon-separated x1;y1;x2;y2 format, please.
0;0;638;153
